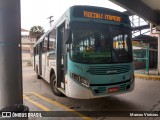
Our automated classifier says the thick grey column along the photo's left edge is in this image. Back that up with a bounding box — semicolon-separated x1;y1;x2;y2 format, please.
0;0;23;110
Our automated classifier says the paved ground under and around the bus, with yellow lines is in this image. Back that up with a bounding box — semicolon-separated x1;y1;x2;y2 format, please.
23;67;160;120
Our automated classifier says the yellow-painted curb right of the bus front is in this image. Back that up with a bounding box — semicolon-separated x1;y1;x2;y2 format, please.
134;74;160;80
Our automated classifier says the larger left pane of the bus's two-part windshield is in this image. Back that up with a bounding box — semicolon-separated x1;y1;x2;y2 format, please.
70;24;111;64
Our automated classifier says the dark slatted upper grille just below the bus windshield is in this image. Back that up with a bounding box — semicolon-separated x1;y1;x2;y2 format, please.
86;65;130;75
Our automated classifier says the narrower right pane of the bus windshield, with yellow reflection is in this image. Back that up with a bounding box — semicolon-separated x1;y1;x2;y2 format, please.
110;26;132;62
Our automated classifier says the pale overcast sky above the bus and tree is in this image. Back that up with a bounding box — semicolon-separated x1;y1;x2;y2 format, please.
21;0;125;31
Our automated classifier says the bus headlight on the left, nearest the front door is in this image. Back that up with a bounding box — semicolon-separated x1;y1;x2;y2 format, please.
70;72;89;87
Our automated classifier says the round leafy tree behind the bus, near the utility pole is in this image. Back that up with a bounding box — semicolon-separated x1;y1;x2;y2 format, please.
29;26;44;41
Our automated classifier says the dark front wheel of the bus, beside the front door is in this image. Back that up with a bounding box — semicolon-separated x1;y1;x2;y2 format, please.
50;75;63;96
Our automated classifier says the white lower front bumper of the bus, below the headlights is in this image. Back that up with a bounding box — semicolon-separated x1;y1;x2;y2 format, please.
66;78;135;99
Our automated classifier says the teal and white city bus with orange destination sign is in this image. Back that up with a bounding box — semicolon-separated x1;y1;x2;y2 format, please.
34;5;134;99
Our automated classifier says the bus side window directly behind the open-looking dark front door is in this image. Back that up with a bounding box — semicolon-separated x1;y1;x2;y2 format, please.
48;29;56;51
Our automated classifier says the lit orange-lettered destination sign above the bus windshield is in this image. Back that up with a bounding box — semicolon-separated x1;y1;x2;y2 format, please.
83;11;121;22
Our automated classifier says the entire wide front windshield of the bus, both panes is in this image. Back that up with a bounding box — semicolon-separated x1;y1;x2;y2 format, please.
70;24;132;64
